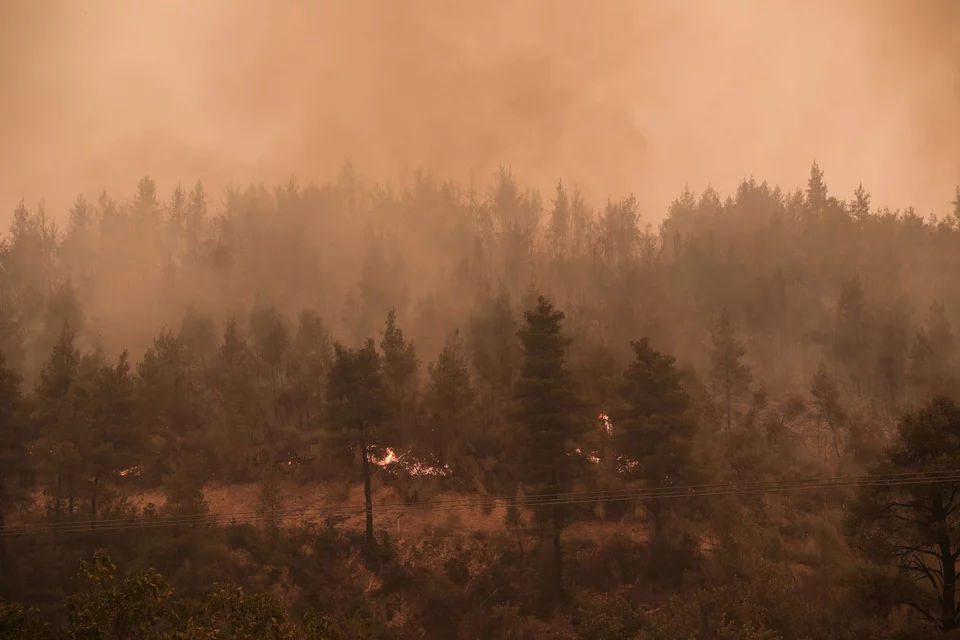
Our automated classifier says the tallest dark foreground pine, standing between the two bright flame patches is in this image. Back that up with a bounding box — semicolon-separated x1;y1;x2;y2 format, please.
516;296;587;589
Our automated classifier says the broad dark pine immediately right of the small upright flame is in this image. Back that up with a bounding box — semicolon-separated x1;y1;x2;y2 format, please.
611;338;697;535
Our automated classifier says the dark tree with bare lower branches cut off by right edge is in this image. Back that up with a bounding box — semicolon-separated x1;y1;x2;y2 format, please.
847;397;960;633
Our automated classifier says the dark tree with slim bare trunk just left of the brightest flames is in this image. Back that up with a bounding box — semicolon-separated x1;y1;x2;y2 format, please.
327;338;389;545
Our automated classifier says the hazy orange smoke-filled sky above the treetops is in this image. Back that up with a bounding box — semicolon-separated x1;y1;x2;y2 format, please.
0;0;960;226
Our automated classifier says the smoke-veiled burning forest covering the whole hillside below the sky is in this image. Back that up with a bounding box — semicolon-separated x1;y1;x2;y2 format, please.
0;163;960;640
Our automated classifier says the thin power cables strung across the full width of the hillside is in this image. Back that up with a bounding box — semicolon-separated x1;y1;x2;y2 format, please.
0;470;960;536
